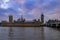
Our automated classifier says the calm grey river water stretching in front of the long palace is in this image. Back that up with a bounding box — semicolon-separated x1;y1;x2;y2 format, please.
0;27;60;40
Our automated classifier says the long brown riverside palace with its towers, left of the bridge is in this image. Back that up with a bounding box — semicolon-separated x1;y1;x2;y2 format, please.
1;14;44;26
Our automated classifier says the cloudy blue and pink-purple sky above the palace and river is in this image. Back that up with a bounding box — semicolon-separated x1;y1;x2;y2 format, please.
0;0;60;21
